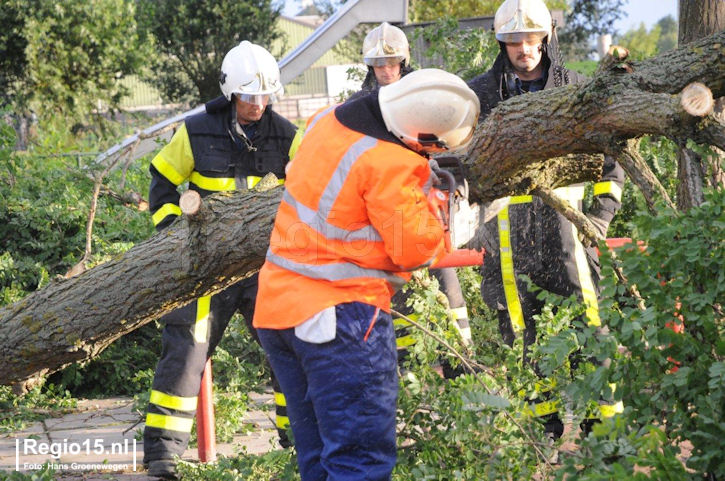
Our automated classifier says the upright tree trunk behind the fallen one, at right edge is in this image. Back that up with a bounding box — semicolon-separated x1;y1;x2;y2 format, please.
677;0;725;210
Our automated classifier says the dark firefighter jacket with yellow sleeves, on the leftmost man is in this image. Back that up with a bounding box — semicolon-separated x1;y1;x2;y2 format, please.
149;97;302;230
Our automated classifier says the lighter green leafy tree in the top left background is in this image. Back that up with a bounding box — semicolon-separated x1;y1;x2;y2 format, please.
22;0;150;122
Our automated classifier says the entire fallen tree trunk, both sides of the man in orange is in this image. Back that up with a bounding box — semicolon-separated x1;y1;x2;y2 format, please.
0;32;725;385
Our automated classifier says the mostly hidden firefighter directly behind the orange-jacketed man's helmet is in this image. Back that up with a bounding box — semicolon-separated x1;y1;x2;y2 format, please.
347;22;471;352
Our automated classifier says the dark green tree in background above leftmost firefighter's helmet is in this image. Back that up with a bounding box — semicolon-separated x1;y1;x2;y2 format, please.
137;0;281;102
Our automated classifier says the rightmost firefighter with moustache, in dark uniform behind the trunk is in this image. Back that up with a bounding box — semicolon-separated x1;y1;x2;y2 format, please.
469;0;624;438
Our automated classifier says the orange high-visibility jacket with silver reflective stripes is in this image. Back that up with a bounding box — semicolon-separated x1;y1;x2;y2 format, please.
254;108;445;329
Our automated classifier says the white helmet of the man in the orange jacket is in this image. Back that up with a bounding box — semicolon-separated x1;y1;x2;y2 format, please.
378;68;481;153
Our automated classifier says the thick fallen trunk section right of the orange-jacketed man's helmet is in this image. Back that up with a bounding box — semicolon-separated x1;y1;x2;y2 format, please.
465;31;725;201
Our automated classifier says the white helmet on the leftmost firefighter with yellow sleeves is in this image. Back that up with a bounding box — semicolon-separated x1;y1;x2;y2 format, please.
219;40;284;103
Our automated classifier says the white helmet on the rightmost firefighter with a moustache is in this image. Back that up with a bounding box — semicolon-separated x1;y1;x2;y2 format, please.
493;0;552;43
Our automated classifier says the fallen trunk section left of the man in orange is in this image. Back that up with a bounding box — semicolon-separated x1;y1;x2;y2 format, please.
0;188;282;384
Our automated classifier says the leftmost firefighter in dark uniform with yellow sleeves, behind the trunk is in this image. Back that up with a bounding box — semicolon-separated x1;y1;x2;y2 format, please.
144;41;301;479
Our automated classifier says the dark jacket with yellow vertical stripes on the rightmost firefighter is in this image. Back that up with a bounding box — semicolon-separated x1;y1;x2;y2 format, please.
469;51;624;330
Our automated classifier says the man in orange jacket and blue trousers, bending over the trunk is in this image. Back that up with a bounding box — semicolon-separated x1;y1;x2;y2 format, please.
254;69;479;481
